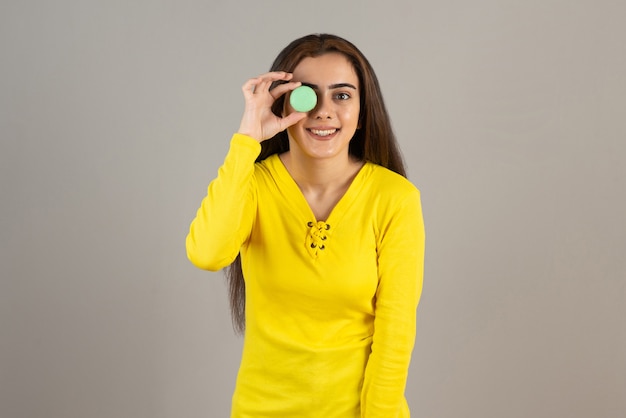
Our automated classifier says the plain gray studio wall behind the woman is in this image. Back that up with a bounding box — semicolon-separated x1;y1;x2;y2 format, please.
0;0;626;418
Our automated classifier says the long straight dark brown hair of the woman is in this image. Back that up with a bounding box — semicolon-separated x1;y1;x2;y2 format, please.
226;34;406;333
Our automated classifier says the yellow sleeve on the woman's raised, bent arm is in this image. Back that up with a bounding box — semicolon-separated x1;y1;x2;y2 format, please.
186;134;261;271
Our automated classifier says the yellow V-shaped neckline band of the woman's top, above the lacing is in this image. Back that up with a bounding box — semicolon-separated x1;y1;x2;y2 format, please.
270;154;370;225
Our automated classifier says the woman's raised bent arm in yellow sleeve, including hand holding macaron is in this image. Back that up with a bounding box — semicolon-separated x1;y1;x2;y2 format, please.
186;72;306;271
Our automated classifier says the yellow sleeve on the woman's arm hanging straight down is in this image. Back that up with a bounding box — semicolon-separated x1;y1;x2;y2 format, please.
361;189;425;418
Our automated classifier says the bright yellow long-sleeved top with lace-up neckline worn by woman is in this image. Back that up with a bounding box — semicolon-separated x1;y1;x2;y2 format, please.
187;134;424;418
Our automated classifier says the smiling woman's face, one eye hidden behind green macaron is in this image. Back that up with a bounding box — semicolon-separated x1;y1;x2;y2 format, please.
285;52;360;159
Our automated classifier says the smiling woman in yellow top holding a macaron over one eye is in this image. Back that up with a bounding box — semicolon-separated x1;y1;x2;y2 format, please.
186;34;424;418
